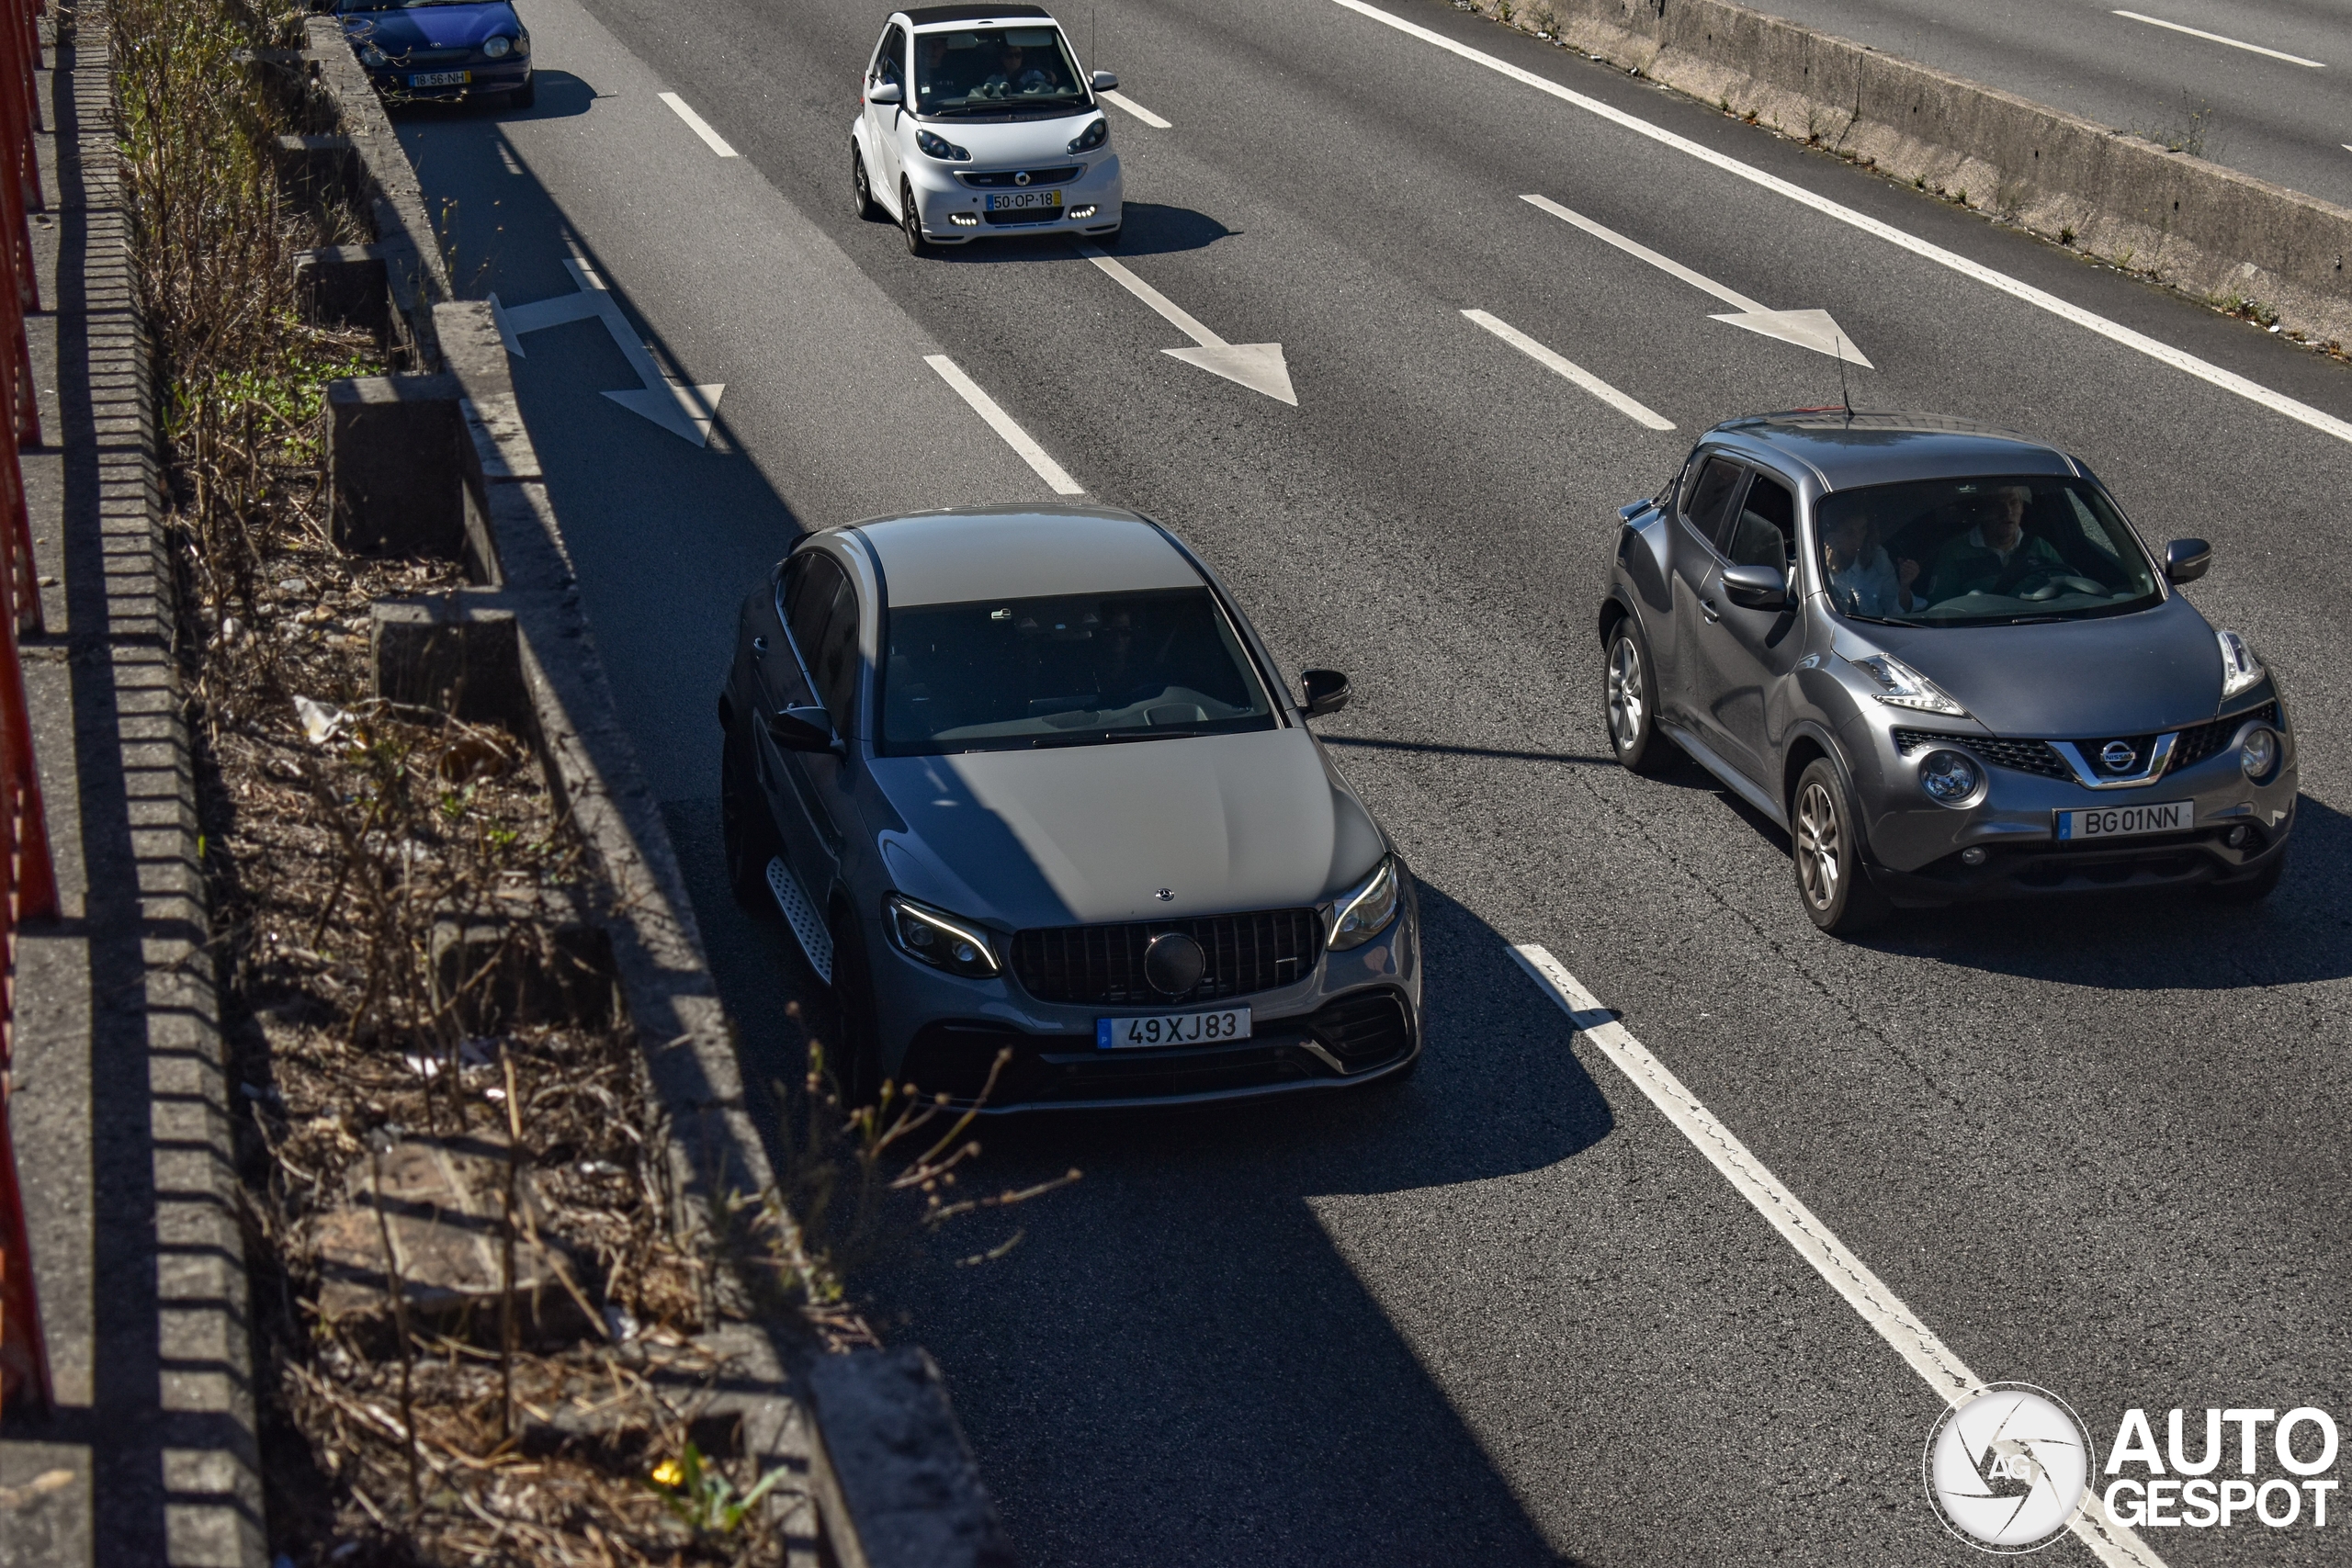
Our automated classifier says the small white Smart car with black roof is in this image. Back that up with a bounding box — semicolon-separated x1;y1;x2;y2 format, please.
849;5;1122;256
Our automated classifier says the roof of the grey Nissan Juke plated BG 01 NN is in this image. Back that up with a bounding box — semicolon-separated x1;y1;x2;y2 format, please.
1708;409;2084;489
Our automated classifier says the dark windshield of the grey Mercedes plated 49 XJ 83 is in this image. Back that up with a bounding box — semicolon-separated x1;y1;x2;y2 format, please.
882;588;1275;752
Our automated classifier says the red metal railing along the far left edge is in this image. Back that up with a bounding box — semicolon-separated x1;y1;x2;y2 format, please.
0;0;56;1408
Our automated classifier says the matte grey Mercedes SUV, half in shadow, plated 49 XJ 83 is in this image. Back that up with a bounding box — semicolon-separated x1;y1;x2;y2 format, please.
719;505;1420;1112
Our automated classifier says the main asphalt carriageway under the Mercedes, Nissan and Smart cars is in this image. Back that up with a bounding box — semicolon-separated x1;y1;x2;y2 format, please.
390;0;2352;1565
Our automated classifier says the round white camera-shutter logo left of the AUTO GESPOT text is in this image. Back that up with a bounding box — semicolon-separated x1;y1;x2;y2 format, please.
1922;1382;2096;1554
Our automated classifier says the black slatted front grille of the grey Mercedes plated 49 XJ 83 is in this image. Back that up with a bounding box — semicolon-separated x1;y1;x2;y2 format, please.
1013;909;1324;1006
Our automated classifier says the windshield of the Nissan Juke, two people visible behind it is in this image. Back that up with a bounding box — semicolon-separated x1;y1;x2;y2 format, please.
1814;475;2164;626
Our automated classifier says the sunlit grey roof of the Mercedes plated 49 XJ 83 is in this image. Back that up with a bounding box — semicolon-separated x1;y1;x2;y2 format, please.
849;505;1202;606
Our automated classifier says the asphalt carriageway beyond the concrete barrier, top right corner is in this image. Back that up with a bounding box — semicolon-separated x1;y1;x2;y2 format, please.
1731;0;2352;207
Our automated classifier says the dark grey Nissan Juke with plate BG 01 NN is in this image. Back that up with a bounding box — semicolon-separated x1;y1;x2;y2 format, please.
1597;409;2296;933
